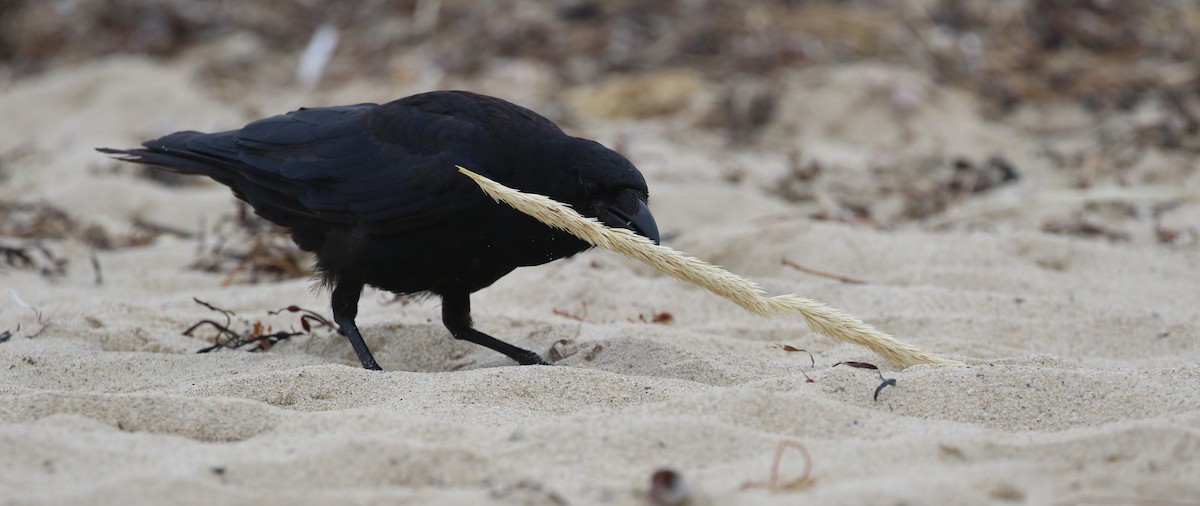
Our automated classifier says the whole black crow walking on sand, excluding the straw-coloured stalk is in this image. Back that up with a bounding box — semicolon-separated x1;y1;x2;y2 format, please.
98;91;659;369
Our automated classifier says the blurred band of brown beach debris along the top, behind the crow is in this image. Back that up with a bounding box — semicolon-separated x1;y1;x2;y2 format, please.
0;0;1200;124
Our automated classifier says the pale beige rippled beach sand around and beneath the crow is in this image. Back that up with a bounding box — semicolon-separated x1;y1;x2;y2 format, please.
0;58;1200;505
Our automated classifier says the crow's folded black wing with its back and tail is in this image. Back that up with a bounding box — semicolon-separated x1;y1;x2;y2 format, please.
111;92;552;233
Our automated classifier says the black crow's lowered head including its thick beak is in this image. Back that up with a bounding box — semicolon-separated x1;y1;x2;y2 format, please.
566;139;659;245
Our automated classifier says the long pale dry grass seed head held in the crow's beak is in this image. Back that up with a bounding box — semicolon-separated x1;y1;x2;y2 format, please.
458;167;961;367
